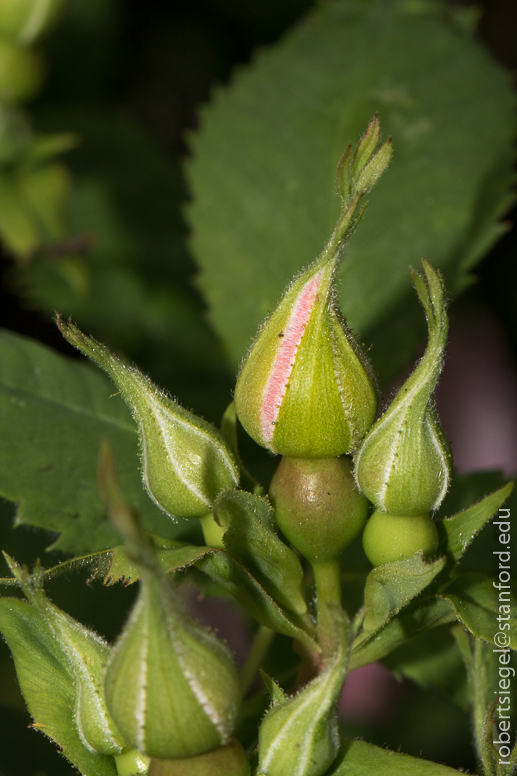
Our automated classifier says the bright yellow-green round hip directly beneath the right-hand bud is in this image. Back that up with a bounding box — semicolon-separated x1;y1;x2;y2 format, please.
363;512;438;566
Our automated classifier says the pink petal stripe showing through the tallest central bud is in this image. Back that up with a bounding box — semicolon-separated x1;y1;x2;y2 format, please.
260;270;323;442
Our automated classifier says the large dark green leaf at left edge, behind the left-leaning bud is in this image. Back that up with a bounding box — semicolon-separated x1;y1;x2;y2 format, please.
0;331;185;554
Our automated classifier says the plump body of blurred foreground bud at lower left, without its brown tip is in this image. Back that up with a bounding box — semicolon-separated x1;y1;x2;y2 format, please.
105;570;239;759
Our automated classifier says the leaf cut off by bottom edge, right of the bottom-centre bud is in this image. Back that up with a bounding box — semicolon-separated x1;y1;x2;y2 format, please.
329;741;466;776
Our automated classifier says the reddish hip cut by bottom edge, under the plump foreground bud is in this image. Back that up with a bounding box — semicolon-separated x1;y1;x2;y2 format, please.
148;739;250;776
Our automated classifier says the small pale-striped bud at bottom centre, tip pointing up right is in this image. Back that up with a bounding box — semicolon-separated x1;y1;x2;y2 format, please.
257;608;347;776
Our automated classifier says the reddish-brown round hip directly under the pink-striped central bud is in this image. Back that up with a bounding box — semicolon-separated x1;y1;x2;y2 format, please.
269;457;368;563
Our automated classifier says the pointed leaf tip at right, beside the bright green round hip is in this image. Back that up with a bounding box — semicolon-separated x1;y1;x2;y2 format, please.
437;482;513;562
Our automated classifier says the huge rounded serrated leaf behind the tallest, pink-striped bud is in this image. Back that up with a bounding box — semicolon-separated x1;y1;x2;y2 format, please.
188;0;514;379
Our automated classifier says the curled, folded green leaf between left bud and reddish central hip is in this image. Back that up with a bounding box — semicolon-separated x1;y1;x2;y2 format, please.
214;490;307;614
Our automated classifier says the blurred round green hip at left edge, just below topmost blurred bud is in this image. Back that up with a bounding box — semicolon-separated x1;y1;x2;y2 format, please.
0;40;42;102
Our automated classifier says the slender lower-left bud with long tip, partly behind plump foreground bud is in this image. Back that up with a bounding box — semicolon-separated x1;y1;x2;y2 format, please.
6;556;127;755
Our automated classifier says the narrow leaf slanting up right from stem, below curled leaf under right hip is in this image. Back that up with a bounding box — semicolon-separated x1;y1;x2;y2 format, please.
350;596;456;670
